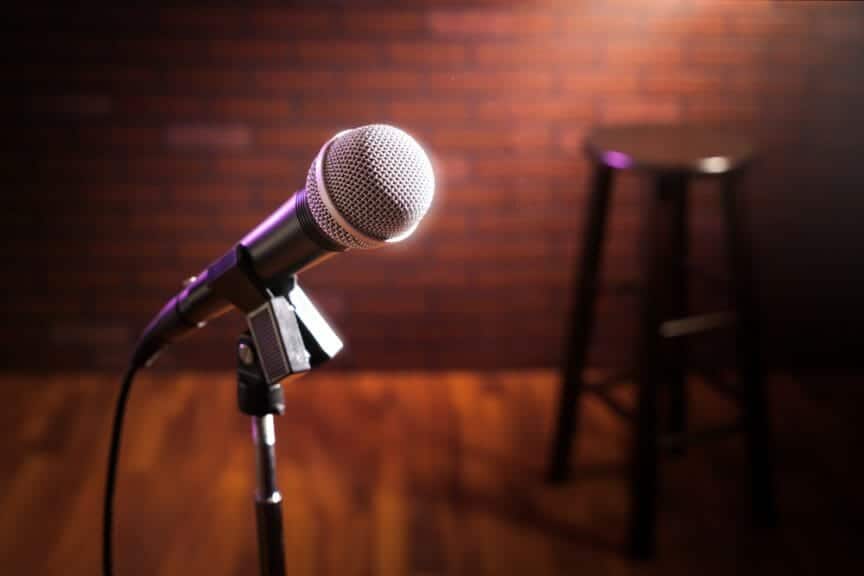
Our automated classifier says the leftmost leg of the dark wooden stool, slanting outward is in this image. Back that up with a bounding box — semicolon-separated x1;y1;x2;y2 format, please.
547;165;612;482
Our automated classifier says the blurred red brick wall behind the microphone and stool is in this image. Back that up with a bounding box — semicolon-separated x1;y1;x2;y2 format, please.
2;0;864;368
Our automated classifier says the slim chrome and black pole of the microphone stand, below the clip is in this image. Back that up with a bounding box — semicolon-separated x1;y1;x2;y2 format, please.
252;414;285;576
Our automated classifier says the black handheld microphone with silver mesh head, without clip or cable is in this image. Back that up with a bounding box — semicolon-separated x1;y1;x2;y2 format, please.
132;124;435;366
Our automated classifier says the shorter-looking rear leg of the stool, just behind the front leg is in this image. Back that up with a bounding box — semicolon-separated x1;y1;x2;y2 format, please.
661;174;688;453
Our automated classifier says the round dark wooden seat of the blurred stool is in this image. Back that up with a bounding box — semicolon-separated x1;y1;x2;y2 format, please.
586;124;754;174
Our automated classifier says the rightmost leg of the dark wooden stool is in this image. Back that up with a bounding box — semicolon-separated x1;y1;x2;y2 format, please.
723;173;775;525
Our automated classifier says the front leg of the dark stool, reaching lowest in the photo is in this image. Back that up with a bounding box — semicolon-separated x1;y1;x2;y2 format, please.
630;175;677;560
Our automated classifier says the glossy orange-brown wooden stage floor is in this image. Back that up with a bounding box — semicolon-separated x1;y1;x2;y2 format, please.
0;371;864;576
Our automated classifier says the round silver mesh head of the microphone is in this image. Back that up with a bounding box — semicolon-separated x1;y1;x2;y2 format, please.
306;124;435;248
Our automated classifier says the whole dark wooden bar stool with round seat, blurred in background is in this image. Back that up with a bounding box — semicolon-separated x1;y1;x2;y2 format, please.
548;125;774;559
